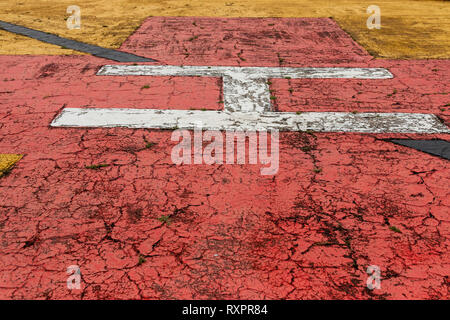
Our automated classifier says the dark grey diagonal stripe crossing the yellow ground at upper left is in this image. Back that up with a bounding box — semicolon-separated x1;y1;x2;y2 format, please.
0;20;157;62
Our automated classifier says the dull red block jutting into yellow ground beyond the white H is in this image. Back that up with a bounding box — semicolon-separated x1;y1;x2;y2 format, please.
121;17;372;67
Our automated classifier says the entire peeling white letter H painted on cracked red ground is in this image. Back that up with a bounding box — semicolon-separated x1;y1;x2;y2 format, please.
51;65;450;133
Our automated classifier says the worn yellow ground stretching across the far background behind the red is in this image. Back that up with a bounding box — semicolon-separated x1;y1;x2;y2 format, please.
0;0;450;59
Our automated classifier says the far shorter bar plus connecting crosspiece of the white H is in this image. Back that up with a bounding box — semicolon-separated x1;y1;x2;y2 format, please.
97;65;393;112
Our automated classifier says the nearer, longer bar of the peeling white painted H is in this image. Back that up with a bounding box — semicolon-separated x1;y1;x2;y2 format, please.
51;108;450;133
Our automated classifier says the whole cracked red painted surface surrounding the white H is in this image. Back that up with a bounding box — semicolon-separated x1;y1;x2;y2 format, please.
0;18;450;299
